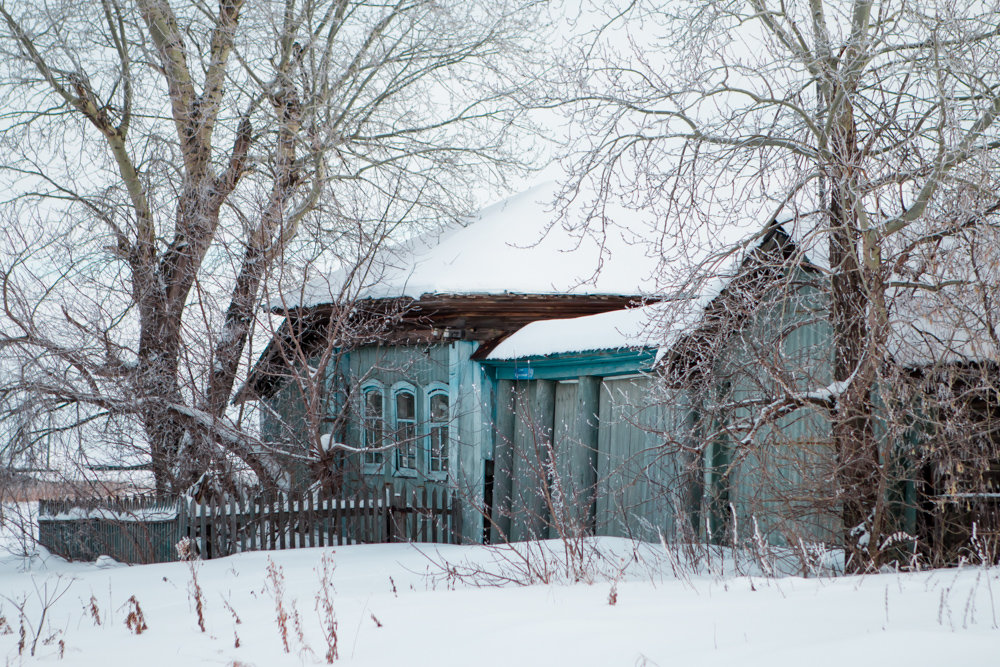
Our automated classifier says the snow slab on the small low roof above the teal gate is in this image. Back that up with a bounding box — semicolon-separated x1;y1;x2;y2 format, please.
487;303;667;360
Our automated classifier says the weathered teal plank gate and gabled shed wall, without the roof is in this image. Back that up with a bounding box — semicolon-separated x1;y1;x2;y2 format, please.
494;272;841;545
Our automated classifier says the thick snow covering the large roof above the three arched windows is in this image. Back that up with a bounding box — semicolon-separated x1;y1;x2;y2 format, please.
282;182;659;307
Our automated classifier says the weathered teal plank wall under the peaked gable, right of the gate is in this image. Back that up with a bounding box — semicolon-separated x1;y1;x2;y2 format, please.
693;271;839;545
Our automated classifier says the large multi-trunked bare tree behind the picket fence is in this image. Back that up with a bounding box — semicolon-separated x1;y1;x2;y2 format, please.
0;0;533;490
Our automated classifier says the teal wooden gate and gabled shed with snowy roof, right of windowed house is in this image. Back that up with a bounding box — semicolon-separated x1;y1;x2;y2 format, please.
484;224;839;544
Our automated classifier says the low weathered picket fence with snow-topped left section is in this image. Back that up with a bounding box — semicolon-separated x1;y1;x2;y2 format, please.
38;486;461;563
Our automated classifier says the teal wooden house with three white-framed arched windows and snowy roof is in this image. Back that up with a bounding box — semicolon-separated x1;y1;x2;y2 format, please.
239;185;657;541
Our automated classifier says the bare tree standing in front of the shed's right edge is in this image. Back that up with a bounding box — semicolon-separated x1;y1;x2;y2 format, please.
557;0;1000;567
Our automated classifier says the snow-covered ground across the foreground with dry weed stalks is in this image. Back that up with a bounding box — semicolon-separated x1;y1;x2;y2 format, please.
0;516;1000;667
